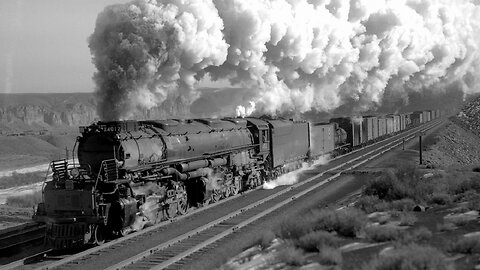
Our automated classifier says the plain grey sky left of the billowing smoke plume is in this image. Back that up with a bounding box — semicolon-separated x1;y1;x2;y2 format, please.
0;0;131;93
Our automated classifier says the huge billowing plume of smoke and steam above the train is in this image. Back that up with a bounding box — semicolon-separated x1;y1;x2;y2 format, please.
89;0;480;120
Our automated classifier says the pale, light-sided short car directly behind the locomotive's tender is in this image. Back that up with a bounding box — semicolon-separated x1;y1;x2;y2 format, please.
310;123;336;158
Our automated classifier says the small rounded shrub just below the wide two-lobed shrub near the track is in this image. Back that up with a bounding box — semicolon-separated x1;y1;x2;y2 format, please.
294;231;340;252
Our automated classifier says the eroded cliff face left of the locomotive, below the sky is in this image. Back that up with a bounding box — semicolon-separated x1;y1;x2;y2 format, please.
0;93;98;132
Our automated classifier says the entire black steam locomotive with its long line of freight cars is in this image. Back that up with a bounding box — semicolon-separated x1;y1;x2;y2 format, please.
34;109;439;249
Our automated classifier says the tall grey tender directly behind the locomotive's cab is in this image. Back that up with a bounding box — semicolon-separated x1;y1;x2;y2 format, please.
267;120;310;168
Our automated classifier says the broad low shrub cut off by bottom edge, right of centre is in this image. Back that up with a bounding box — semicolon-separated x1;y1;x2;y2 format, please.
362;244;453;270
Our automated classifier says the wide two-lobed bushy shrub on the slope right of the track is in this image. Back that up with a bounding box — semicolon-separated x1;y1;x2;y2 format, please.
312;208;367;237
